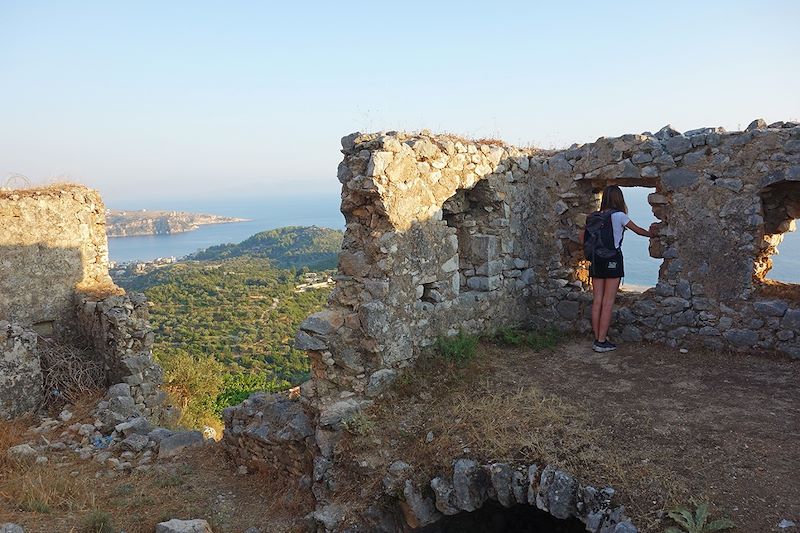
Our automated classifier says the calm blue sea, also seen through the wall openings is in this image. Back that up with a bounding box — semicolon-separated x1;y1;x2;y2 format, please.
108;187;800;284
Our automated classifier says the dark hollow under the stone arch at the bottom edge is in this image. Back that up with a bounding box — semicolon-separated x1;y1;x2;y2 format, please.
413;501;586;533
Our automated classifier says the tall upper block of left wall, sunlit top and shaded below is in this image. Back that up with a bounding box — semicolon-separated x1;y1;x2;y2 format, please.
0;185;112;338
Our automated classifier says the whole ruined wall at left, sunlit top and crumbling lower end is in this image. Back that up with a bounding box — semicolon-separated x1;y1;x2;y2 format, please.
0;185;165;422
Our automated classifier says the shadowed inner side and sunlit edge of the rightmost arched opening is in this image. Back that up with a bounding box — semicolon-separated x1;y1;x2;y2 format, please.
753;180;800;282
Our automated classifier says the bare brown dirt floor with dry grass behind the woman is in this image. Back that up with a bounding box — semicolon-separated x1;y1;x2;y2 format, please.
339;339;800;532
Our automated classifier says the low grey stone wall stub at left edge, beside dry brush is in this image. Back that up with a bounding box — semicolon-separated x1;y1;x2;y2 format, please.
0;320;43;420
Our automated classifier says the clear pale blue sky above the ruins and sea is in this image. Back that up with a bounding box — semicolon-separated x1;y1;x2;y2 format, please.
0;0;800;208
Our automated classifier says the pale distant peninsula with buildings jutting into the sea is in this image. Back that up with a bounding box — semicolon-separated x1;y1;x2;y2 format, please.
106;209;247;237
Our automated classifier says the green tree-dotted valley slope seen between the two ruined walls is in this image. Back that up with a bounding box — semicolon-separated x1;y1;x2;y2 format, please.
115;228;332;427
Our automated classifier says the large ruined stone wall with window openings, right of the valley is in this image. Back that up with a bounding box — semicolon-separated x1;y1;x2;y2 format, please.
226;121;800;530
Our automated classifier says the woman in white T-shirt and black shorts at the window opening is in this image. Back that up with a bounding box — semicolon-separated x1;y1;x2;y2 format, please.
580;185;653;352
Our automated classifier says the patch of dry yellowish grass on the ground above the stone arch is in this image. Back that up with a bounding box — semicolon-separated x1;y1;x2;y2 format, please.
337;344;687;523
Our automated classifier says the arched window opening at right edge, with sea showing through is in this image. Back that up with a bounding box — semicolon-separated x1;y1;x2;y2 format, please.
753;181;800;291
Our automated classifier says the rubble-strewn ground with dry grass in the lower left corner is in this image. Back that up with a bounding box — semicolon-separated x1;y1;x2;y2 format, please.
0;392;313;533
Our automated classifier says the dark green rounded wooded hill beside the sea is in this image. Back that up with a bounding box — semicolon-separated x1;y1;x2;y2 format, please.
192;226;343;270
